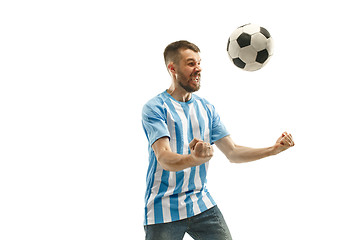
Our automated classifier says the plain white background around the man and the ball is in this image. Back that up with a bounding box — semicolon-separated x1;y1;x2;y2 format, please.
0;0;360;240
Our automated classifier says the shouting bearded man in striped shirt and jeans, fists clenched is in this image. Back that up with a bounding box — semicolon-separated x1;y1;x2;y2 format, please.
142;41;294;240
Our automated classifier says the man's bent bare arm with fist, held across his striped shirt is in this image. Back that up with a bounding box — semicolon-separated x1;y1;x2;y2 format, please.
152;137;214;172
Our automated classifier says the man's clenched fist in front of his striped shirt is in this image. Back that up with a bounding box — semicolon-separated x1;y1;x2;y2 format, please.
189;138;214;162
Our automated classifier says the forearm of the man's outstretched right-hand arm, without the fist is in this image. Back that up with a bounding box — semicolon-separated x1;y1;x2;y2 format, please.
227;145;276;163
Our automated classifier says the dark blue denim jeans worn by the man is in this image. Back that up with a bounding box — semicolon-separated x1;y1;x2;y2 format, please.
144;206;232;240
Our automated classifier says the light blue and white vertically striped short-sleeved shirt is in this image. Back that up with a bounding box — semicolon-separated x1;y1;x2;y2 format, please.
142;91;229;225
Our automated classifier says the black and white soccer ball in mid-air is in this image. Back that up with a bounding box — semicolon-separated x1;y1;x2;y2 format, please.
227;23;273;71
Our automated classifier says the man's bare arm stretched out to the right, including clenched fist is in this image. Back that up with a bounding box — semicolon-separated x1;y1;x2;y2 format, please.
215;132;295;163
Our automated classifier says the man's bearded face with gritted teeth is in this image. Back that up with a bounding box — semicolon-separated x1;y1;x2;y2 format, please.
176;49;201;93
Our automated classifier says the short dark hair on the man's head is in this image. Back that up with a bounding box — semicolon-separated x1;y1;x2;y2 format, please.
164;40;200;65
